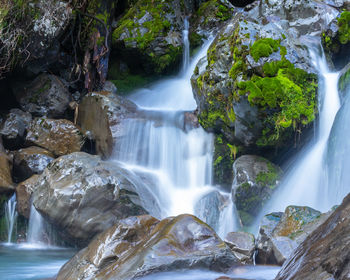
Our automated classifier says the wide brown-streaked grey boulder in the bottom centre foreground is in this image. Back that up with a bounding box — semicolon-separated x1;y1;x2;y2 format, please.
57;215;239;280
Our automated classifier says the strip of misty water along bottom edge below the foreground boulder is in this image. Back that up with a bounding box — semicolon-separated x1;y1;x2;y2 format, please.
142;265;281;280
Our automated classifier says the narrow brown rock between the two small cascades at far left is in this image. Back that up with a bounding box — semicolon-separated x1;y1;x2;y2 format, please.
16;175;39;219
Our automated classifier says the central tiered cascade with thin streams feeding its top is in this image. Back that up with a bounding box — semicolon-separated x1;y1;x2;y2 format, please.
114;21;235;235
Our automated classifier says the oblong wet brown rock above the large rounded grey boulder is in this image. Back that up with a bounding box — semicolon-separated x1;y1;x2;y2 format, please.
25;118;84;156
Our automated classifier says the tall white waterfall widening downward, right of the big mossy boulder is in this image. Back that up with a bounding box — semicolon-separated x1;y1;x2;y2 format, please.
258;48;340;220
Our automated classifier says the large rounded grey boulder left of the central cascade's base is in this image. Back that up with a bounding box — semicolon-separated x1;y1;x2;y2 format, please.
33;152;147;246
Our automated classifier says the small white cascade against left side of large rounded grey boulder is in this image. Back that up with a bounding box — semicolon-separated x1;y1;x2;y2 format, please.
27;204;45;244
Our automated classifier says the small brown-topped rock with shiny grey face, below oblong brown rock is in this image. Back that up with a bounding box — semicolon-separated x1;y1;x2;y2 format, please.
13;146;54;181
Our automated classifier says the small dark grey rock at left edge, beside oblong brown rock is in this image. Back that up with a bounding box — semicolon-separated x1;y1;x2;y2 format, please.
0;109;32;150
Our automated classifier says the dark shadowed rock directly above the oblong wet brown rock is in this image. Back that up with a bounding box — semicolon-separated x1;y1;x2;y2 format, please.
13;74;71;118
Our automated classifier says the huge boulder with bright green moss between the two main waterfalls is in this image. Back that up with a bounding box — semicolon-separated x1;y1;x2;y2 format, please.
191;1;337;155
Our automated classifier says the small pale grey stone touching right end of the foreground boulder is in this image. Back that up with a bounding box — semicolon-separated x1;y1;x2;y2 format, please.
225;232;255;264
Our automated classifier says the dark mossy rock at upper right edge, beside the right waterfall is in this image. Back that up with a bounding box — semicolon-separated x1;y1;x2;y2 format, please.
322;10;350;70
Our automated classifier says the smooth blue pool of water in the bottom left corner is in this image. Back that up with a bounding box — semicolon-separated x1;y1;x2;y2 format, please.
0;243;75;280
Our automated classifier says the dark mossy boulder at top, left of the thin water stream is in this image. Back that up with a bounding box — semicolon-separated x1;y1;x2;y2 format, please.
112;0;184;74
